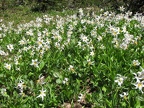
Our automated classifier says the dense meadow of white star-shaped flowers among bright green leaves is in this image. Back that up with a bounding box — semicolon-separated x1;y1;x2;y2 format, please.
0;7;144;108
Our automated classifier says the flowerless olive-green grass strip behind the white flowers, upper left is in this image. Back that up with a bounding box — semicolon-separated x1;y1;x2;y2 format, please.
0;5;76;25
